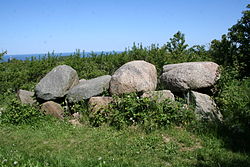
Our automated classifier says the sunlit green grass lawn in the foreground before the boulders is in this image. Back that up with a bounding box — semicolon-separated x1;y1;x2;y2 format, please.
0;120;250;167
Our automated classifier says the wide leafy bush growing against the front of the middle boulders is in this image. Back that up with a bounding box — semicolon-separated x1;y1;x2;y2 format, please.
90;93;194;130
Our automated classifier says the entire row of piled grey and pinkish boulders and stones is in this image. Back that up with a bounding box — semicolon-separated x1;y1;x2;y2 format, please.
17;60;222;124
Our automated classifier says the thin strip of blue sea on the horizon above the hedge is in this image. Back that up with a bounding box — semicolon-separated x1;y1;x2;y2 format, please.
3;51;121;62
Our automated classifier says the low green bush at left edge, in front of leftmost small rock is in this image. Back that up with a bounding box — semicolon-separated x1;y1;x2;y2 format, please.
0;99;42;125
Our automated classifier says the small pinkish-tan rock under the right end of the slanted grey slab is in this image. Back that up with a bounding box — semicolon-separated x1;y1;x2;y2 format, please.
89;96;113;112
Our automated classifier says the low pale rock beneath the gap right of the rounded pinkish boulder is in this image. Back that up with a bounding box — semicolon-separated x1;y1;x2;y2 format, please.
141;90;174;103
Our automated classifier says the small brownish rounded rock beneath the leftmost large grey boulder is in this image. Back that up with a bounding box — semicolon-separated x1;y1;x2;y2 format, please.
41;101;64;119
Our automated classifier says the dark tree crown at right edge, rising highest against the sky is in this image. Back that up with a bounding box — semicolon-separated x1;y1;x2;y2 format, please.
210;5;250;77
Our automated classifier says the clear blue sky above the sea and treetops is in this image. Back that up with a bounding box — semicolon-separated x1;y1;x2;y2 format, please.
0;0;249;54
